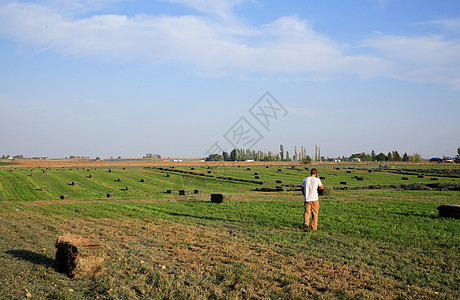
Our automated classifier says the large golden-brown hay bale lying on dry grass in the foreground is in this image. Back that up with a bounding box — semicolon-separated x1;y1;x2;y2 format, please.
54;234;104;278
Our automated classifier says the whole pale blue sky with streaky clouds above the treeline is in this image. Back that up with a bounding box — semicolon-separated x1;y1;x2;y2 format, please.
0;0;460;158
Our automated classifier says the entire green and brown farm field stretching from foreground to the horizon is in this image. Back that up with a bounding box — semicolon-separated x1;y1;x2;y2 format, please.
0;162;460;299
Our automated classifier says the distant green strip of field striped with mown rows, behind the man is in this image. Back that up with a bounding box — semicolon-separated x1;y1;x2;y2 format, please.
0;166;460;201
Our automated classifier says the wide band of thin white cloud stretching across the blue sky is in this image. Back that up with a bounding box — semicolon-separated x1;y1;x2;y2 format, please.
0;0;460;87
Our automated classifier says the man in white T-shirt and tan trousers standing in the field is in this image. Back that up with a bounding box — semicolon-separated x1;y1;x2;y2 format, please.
302;168;324;231
